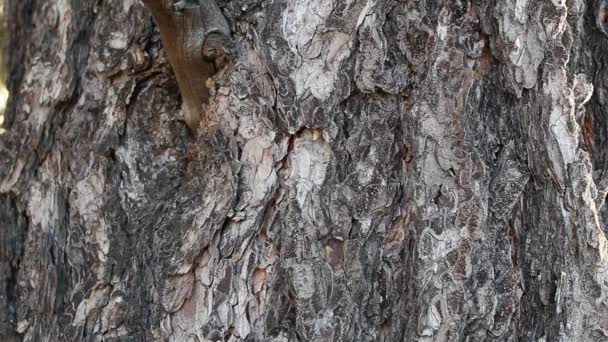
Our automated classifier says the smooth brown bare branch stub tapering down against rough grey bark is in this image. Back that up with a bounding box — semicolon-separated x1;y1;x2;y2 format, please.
144;0;230;132
